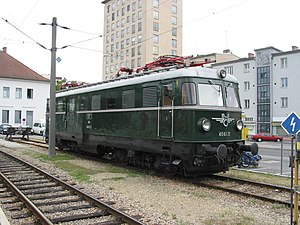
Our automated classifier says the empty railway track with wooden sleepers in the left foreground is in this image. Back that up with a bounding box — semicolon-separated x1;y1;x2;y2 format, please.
0;151;143;225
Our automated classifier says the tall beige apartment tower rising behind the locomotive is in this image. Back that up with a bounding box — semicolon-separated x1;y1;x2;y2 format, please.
102;0;182;80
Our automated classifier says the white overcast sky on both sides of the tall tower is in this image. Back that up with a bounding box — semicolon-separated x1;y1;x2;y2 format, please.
0;0;300;82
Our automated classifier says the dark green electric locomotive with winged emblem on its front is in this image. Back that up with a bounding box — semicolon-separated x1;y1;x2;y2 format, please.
52;61;258;176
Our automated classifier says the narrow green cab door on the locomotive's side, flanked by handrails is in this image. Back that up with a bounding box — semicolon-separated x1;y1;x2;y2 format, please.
159;82;174;138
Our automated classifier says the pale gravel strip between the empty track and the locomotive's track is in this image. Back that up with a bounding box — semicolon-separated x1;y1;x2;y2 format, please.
0;139;290;225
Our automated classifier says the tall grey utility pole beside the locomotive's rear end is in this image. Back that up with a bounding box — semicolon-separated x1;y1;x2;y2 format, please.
48;17;57;157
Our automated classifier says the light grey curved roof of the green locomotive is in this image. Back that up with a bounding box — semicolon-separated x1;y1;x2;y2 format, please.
56;67;238;97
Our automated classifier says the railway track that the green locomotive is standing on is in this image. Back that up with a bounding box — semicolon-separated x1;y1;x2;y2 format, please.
8;141;300;209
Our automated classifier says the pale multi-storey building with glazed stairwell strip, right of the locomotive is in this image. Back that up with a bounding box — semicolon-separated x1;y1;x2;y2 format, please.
213;46;300;135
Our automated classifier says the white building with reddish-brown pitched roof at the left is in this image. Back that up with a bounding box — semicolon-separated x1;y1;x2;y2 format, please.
0;48;50;127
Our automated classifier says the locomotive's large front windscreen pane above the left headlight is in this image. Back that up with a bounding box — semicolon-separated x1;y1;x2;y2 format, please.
198;84;224;106
